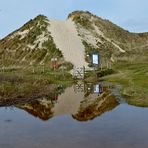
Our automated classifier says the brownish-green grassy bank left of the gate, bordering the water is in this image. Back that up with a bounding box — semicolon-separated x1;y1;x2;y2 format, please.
0;67;73;101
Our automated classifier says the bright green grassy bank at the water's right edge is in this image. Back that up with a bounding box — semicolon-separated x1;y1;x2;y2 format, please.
102;63;148;106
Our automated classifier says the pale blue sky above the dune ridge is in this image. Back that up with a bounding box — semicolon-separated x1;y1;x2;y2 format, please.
0;0;148;38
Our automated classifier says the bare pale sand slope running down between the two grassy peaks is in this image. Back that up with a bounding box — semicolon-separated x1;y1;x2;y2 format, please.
49;20;87;67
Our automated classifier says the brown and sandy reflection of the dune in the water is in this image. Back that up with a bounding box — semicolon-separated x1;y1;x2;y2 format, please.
8;82;119;121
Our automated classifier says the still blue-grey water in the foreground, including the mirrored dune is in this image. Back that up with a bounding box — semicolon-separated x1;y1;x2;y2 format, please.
0;84;148;148
